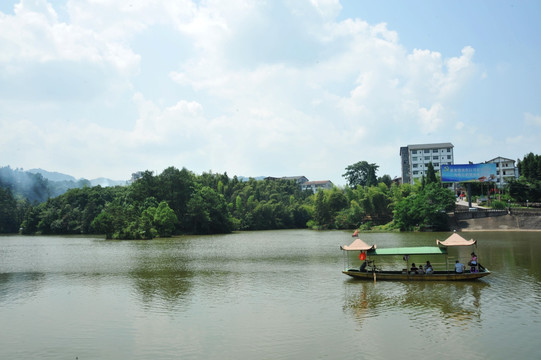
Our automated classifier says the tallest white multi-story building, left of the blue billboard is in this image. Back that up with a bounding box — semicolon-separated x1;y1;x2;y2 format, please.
400;143;455;184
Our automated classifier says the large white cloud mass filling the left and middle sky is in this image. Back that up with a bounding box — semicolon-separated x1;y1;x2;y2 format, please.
0;0;480;181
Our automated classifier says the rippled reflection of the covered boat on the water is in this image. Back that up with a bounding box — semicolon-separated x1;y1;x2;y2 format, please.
344;279;490;330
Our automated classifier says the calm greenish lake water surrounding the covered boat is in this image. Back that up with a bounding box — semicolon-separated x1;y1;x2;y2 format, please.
0;230;541;360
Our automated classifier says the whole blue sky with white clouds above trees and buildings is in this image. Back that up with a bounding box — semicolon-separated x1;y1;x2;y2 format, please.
0;0;541;185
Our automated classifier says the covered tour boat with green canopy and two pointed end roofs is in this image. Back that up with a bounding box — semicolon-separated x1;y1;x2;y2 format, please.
340;232;490;281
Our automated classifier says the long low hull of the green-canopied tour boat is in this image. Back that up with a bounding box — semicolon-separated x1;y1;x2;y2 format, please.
342;269;490;281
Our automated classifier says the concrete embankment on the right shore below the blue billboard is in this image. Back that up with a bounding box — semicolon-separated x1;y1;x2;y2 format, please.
449;209;541;231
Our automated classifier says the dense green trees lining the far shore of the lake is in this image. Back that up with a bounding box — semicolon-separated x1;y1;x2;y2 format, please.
0;153;541;239
